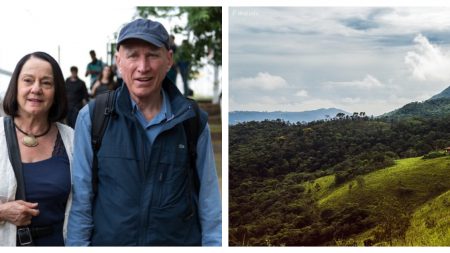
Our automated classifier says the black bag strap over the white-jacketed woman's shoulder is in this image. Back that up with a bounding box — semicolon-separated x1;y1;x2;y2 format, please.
3;117;25;200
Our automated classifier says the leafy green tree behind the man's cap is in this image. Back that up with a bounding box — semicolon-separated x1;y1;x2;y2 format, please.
137;6;222;77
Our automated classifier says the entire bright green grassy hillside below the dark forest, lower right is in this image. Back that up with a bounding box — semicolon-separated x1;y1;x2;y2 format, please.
318;156;450;245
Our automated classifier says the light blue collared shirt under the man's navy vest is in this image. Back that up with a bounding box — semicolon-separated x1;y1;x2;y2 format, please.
66;90;222;246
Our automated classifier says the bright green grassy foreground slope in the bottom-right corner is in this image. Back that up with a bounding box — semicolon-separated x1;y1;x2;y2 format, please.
406;191;450;246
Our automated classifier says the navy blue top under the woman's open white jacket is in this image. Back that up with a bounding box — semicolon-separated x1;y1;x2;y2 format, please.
22;133;71;246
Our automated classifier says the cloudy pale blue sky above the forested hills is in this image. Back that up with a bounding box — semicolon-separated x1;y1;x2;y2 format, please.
229;7;450;115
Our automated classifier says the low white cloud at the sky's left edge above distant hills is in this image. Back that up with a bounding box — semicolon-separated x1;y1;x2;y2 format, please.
231;72;288;91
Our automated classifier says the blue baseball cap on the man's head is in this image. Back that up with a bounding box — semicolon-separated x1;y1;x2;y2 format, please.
117;19;169;50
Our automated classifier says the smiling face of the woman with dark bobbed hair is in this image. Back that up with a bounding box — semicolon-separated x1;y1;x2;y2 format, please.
17;57;55;117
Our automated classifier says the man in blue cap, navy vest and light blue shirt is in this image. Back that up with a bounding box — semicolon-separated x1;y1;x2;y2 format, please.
66;19;222;246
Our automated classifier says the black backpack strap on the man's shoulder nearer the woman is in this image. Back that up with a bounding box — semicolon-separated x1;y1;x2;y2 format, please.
89;91;116;196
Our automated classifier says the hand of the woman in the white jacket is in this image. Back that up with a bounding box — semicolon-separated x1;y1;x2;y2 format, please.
0;200;39;226
